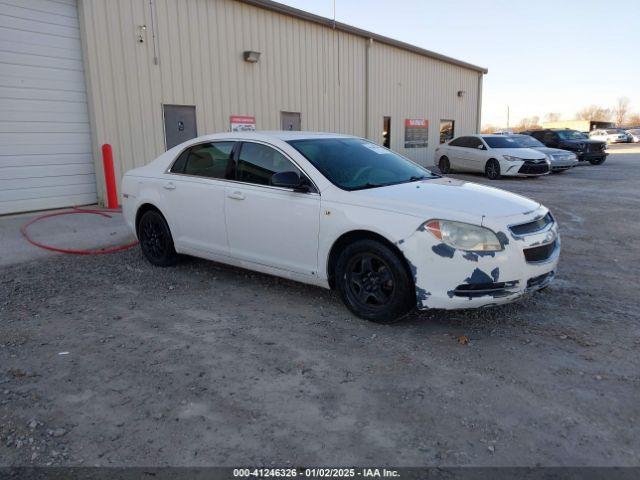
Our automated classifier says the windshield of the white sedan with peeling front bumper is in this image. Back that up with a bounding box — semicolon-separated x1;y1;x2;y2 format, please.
288;138;439;190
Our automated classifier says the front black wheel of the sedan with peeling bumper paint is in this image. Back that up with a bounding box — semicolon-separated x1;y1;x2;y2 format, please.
335;239;416;323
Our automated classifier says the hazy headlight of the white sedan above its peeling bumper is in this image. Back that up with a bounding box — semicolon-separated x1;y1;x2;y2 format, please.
423;220;502;252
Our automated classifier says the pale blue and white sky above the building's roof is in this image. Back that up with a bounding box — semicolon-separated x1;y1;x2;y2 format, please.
278;0;640;126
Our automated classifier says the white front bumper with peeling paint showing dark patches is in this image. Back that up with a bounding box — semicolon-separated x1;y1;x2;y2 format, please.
400;208;560;310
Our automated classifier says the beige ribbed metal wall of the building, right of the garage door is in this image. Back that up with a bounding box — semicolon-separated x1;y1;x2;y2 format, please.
79;0;480;198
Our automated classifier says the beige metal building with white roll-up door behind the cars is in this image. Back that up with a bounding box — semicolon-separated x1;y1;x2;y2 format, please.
0;0;487;214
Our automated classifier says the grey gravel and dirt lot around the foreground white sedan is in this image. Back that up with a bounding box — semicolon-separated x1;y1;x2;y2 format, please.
0;147;640;466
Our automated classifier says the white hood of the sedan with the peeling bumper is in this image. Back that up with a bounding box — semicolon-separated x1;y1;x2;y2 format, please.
336;177;540;222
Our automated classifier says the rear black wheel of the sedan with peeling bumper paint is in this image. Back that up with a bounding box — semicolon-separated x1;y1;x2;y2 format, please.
138;210;178;267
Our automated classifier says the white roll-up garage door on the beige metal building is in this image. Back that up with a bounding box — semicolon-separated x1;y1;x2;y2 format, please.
0;0;96;214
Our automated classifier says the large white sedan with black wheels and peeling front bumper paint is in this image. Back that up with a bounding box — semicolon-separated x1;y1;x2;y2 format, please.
122;132;560;322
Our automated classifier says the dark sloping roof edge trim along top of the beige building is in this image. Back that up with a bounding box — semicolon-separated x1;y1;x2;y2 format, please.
237;0;489;74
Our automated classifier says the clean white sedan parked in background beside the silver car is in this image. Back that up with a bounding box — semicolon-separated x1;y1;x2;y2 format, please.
435;134;551;180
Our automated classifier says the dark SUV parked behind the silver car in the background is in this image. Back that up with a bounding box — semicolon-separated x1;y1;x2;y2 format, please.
521;128;609;165
